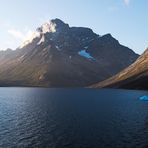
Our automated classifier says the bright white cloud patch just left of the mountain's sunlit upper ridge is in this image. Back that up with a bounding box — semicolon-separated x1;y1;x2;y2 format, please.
8;29;33;41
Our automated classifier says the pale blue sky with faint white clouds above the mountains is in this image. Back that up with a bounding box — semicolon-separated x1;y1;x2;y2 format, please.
0;0;148;54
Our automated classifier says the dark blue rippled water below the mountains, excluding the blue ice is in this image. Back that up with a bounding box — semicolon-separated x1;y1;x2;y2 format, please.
0;88;148;148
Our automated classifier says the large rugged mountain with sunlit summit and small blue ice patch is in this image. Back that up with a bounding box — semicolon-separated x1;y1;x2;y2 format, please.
0;19;138;87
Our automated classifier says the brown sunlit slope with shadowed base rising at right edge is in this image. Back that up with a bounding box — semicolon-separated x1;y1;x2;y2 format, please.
92;49;148;90
